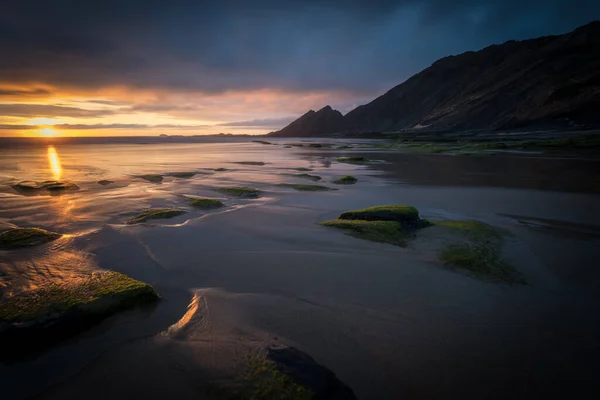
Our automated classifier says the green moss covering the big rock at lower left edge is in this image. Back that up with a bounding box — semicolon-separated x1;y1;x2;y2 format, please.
0;271;158;325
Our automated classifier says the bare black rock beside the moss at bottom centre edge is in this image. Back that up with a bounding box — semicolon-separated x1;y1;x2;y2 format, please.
267;347;356;400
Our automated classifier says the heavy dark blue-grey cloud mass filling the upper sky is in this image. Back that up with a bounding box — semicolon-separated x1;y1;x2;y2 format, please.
0;0;600;93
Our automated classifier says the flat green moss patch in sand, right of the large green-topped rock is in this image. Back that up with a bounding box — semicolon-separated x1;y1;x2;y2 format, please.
436;220;526;284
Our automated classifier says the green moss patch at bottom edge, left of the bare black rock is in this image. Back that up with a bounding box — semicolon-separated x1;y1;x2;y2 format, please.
236;356;314;400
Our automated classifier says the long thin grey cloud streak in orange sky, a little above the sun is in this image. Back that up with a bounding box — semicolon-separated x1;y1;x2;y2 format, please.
0;104;116;118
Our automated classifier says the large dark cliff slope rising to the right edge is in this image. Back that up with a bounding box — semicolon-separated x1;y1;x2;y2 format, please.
275;21;600;136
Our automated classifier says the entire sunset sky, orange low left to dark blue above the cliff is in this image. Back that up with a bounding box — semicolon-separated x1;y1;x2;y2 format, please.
0;0;600;136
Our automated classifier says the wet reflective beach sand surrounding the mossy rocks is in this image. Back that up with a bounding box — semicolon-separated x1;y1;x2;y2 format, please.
0;140;600;399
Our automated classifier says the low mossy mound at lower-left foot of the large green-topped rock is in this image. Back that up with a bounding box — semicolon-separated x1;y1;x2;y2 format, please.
321;219;410;246
